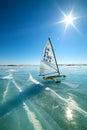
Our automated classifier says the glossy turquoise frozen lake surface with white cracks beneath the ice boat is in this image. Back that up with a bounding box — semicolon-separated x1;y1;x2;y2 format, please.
0;66;87;130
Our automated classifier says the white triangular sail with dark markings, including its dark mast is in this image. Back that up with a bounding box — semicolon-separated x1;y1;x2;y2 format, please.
40;38;60;75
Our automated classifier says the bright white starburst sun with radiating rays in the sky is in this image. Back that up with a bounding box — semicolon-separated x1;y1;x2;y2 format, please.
56;9;80;32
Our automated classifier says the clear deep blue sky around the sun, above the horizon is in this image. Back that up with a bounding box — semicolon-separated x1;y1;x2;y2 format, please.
0;0;87;64
